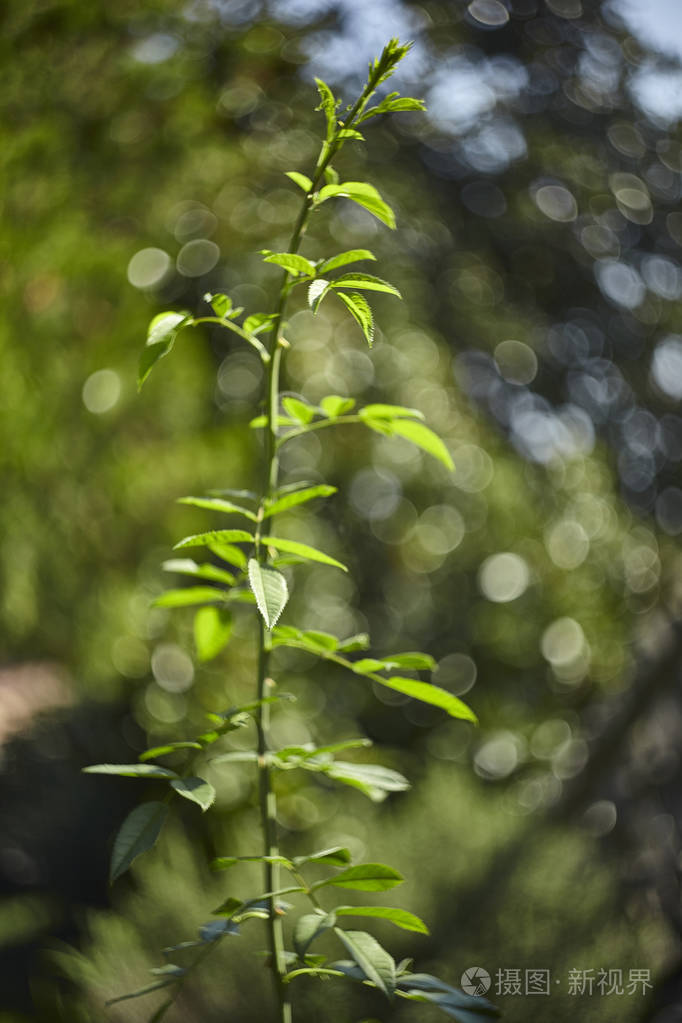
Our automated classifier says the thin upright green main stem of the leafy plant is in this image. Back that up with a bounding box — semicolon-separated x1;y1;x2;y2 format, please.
253;68;394;1023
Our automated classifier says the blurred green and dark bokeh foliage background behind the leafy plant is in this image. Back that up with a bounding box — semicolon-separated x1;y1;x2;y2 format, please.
0;0;682;1023
